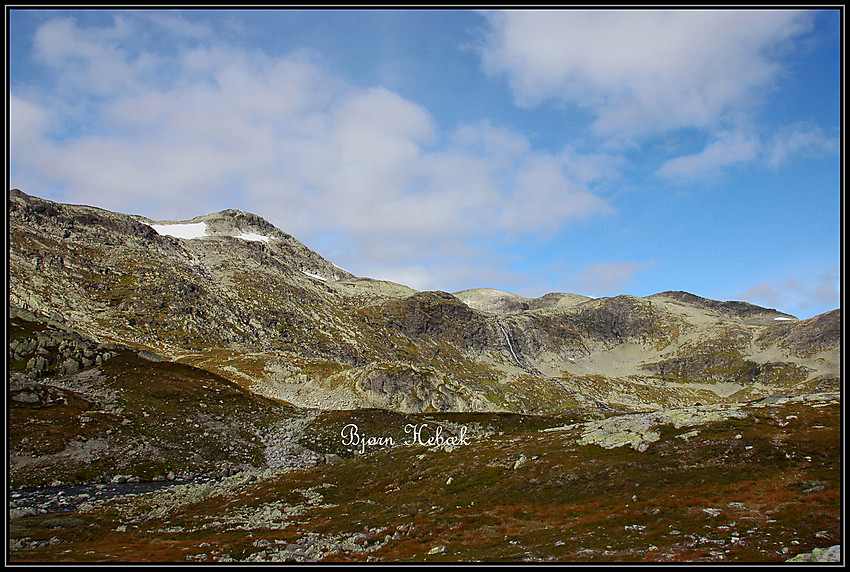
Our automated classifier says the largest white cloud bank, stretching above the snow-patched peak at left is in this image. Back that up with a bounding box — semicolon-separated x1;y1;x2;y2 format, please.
10;16;611;290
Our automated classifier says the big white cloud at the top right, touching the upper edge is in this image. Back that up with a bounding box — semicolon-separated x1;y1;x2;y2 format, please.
480;10;812;139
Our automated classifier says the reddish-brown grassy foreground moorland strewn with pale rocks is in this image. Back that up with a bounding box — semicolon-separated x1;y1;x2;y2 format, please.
4;394;841;563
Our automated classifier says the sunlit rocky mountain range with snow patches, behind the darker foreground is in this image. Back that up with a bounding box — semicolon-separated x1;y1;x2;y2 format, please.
9;190;841;413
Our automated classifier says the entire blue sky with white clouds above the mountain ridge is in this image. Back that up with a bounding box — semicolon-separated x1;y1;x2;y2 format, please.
7;9;842;318
